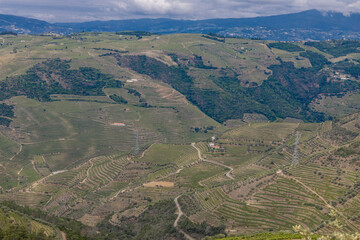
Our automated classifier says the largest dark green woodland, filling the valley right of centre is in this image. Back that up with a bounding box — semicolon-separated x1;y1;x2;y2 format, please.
116;51;360;122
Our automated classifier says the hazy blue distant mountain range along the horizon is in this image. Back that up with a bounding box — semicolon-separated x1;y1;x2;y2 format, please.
0;10;360;41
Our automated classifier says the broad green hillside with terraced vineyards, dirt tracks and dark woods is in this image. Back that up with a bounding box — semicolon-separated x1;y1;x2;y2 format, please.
0;32;360;239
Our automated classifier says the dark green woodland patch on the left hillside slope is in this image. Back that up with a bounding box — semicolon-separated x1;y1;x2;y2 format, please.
0;59;122;101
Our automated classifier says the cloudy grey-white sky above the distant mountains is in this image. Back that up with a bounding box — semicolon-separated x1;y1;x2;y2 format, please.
0;0;360;22
